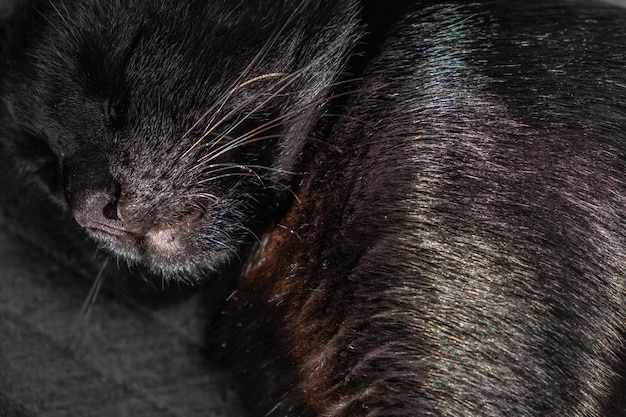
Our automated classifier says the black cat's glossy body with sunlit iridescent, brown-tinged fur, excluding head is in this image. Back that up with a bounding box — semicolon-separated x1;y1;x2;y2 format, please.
223;2;626;416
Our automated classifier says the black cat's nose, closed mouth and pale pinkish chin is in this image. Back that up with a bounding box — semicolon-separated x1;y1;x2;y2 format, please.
66;180;243;280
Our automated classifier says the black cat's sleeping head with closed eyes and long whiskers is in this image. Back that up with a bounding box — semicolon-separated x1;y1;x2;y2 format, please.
2;0;353;277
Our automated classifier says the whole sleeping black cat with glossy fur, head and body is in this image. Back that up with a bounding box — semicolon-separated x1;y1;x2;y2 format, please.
0;0;626;417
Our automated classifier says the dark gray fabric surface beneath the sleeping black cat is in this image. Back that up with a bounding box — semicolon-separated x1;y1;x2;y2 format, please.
0;0;626;417
